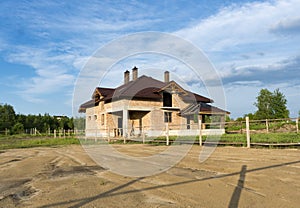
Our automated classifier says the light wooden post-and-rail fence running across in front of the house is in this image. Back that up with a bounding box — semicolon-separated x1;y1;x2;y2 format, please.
0;118;300;147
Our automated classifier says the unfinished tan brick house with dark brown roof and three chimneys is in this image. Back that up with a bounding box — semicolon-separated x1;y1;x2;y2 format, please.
79;67;229;137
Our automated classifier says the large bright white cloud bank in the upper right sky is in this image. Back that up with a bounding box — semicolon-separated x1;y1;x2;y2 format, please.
176;0;300;51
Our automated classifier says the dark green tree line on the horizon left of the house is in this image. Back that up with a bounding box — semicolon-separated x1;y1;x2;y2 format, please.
0;104;85;134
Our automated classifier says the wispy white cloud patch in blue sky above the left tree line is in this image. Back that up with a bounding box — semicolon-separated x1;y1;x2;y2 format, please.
7;46;75;102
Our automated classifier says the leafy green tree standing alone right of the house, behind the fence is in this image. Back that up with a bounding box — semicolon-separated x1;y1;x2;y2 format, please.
254;89;289;119
